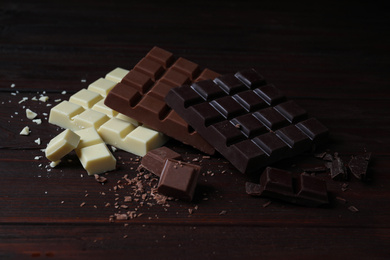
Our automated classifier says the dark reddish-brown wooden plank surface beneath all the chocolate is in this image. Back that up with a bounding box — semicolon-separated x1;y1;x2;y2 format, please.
0;0;390;259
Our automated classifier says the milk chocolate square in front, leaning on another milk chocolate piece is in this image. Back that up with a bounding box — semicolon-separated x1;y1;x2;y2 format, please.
157;159;201;201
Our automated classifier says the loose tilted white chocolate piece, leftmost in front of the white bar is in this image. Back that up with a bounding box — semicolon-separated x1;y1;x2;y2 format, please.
45;129;80;161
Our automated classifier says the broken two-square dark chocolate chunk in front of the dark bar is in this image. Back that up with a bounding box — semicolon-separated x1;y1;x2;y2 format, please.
246;167;329;207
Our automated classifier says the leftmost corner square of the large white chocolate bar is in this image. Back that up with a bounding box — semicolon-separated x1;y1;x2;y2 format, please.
49;100;84;130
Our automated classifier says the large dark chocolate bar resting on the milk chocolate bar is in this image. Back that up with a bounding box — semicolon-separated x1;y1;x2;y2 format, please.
165;69;328;173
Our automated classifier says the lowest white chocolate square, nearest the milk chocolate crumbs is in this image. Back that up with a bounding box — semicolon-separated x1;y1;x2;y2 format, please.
76;143;116;175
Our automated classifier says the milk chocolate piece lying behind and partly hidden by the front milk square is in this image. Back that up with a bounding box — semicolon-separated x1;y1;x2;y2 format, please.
140;146;181;176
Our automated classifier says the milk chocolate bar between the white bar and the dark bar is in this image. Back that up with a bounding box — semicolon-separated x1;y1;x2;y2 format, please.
104;47;219;154
